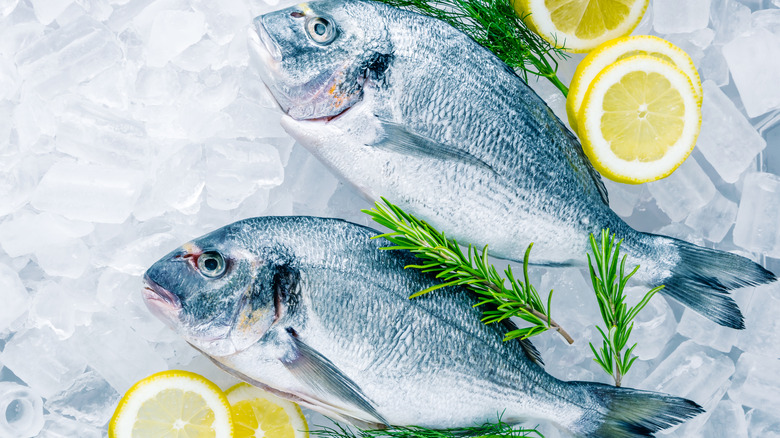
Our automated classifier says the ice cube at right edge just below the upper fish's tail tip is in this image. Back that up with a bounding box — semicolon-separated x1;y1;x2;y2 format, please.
737;283;780;357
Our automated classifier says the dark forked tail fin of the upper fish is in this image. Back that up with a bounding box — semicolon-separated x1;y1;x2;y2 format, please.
658;236;777;329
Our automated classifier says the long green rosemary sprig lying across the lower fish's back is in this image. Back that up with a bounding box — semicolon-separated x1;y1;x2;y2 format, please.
363;198;574;344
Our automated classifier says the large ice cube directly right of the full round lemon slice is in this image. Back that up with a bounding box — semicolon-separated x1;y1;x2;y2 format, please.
697;81;766;183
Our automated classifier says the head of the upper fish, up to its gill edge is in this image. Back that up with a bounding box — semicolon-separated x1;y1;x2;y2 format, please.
249;0;391;120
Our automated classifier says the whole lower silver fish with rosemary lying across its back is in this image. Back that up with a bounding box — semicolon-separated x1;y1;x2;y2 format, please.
143;217;701;437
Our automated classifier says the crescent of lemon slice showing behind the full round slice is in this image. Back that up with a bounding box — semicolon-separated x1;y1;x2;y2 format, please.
566;35;703;132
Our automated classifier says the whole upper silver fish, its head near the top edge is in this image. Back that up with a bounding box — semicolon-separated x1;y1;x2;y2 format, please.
250;0;776;328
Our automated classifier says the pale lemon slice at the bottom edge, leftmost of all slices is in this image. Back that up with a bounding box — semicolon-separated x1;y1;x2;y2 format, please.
108;370;233;438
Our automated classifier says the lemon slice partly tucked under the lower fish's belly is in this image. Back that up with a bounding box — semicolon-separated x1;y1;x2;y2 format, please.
226;383;309;438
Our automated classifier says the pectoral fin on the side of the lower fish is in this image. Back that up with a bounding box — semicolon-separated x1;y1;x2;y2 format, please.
282;329;388;425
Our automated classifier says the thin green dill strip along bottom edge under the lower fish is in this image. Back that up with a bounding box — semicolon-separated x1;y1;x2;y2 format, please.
309;418;544;438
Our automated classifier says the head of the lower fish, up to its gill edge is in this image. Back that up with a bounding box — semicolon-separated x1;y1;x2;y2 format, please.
143;223;284;357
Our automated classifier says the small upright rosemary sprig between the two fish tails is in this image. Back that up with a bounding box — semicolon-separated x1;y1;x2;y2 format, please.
588;229;663;386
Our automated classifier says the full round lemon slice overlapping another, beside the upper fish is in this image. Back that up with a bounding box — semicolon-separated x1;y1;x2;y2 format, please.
577;55;701;184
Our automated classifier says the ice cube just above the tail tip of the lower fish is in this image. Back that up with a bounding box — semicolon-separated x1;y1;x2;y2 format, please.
639;341;734;408
